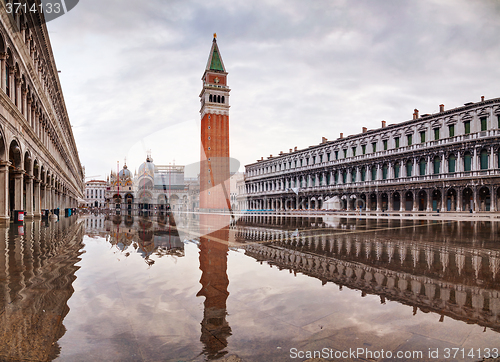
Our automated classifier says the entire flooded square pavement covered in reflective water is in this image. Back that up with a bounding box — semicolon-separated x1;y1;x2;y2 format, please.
0;214;500;361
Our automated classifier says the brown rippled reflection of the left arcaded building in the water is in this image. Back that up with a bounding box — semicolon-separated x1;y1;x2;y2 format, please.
0;217;83;361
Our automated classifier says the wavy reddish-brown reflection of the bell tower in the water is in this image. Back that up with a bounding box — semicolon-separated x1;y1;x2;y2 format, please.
197;214;231;359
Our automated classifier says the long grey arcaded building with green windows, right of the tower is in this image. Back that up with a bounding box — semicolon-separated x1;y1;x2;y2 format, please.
240;97;500;212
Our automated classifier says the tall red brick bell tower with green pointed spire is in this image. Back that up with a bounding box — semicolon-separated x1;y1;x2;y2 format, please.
200;34;231;210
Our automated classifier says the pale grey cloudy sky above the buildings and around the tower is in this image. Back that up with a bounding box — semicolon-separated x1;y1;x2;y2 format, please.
47;0;500;179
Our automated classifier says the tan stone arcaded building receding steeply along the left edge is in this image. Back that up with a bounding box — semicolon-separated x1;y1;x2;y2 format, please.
0;0;84;222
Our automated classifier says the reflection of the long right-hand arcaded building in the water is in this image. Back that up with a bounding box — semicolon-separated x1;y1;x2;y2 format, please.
237;216;500;331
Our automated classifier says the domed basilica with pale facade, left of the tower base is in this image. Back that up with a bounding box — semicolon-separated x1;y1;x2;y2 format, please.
107;156;192;215
